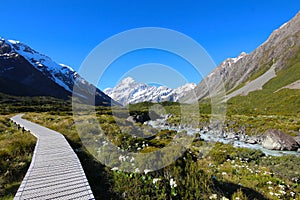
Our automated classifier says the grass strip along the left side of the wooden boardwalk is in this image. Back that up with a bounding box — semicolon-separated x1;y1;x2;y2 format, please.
0;115;36;199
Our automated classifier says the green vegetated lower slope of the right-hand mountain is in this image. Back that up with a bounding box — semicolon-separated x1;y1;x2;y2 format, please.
228;48;300;115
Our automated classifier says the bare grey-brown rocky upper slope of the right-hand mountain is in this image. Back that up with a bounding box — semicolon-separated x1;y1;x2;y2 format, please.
195;12;300;99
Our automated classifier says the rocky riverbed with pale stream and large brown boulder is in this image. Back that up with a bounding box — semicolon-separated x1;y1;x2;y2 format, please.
145;116;300;156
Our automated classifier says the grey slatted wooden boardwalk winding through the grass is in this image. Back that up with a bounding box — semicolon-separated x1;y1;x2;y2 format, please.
11;115;94;200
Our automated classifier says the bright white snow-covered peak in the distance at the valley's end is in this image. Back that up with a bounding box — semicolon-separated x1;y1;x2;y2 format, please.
104;77;196;105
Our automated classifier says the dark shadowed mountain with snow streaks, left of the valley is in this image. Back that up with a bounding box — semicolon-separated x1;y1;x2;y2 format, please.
0;37;115;105
